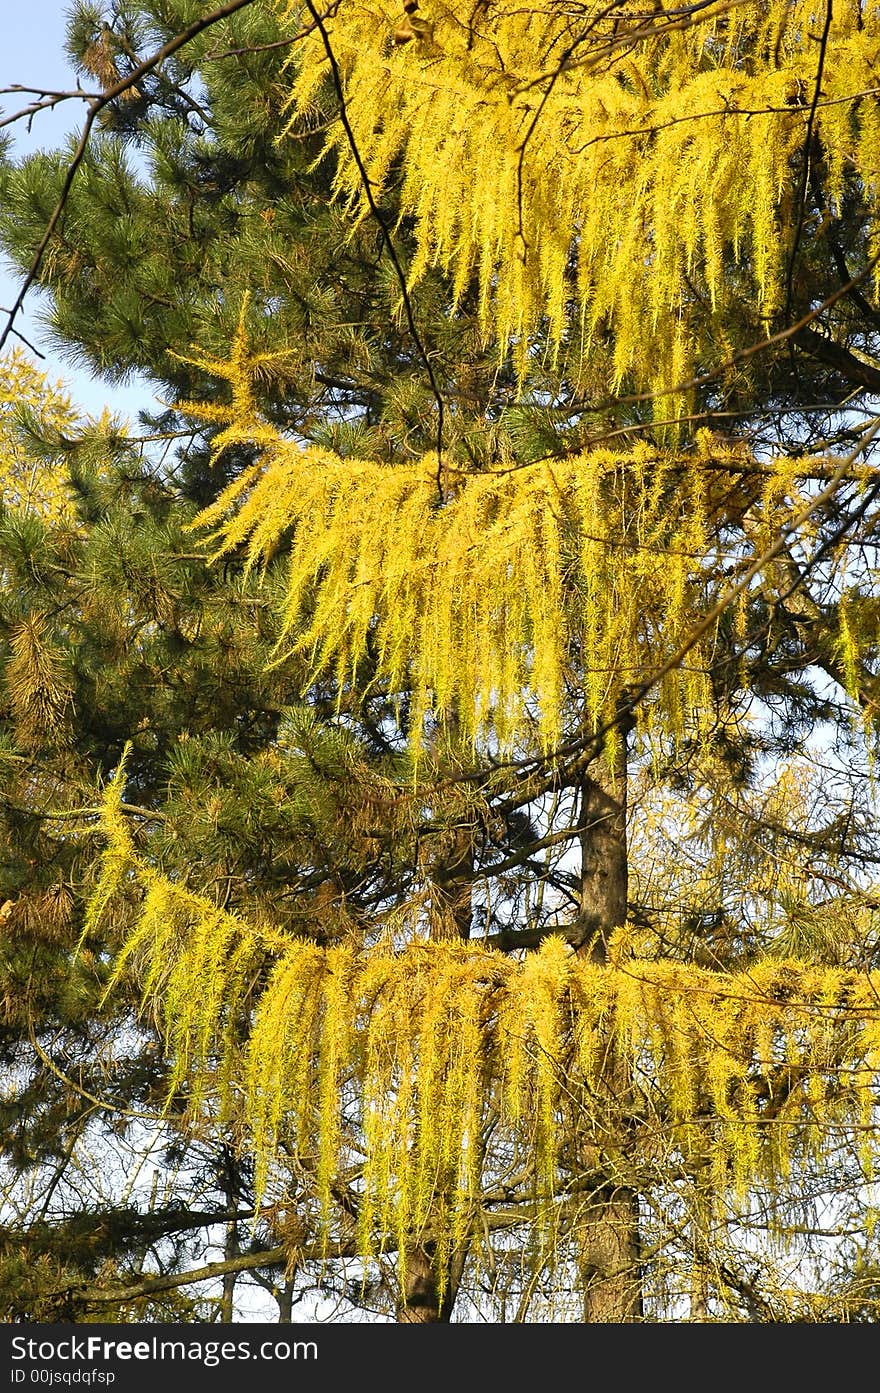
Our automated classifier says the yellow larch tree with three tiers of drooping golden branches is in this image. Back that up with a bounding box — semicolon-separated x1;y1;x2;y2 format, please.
63;0;880;1321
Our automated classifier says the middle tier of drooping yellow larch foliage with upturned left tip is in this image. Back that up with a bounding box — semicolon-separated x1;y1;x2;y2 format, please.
178;327;841;749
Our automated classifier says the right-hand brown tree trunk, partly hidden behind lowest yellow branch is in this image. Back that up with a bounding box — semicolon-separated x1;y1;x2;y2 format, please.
579;730;643;1322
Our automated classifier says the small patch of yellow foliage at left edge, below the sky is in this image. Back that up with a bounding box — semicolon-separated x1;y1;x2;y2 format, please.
0;348;77;521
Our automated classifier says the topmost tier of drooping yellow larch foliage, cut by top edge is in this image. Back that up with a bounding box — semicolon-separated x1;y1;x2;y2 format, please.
277;0;880;390
